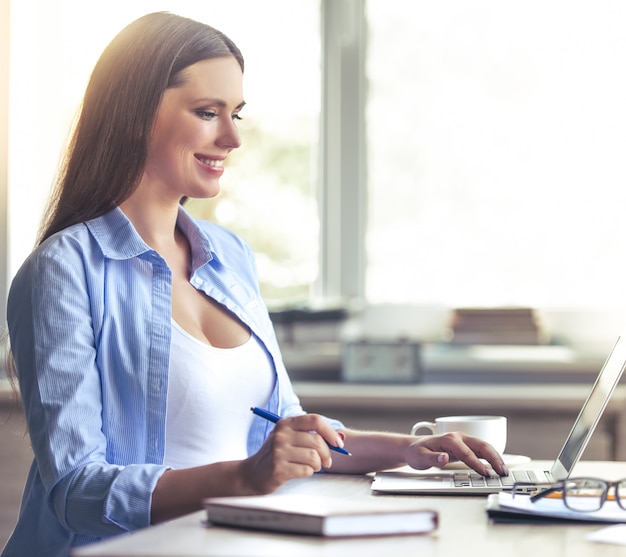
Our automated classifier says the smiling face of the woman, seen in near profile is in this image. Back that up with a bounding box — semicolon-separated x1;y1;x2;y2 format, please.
142;57;244;202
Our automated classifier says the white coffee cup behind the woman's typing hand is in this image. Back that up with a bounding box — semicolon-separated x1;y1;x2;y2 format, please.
411;416;507;454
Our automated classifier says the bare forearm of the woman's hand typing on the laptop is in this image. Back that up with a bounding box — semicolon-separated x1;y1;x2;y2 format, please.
330;429;415;474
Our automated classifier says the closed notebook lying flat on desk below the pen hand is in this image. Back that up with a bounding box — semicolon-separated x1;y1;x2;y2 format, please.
203;494;438;538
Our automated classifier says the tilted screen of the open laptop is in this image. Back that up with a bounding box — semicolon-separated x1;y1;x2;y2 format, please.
552;332;626;480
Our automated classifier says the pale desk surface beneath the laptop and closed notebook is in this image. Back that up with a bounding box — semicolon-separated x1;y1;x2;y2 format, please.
72;461;626;557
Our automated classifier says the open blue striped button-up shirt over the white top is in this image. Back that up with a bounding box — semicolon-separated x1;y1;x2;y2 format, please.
2;208;339;557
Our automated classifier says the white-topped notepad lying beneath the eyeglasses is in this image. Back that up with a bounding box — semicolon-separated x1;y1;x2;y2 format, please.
487;492;626;524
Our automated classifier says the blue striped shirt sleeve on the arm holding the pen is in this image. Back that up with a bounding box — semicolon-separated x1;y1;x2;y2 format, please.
7;238;166;536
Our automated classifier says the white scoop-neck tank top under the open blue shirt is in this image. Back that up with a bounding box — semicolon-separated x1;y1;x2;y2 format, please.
165;320;274;468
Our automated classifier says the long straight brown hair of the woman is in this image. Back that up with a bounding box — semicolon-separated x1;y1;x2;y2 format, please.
38;12;244;243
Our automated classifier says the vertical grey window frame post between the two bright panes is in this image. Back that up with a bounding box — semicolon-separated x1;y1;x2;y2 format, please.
315;0;367;304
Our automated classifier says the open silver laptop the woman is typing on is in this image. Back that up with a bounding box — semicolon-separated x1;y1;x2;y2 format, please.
371;331;626;495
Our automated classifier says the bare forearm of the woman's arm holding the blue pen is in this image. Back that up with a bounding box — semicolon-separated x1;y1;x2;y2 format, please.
151;461;255;524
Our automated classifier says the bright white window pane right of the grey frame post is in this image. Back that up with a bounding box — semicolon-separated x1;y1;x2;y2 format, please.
366;0;626;309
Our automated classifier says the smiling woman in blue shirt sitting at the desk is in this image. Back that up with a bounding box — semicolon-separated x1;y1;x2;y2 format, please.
2;13;507;557
